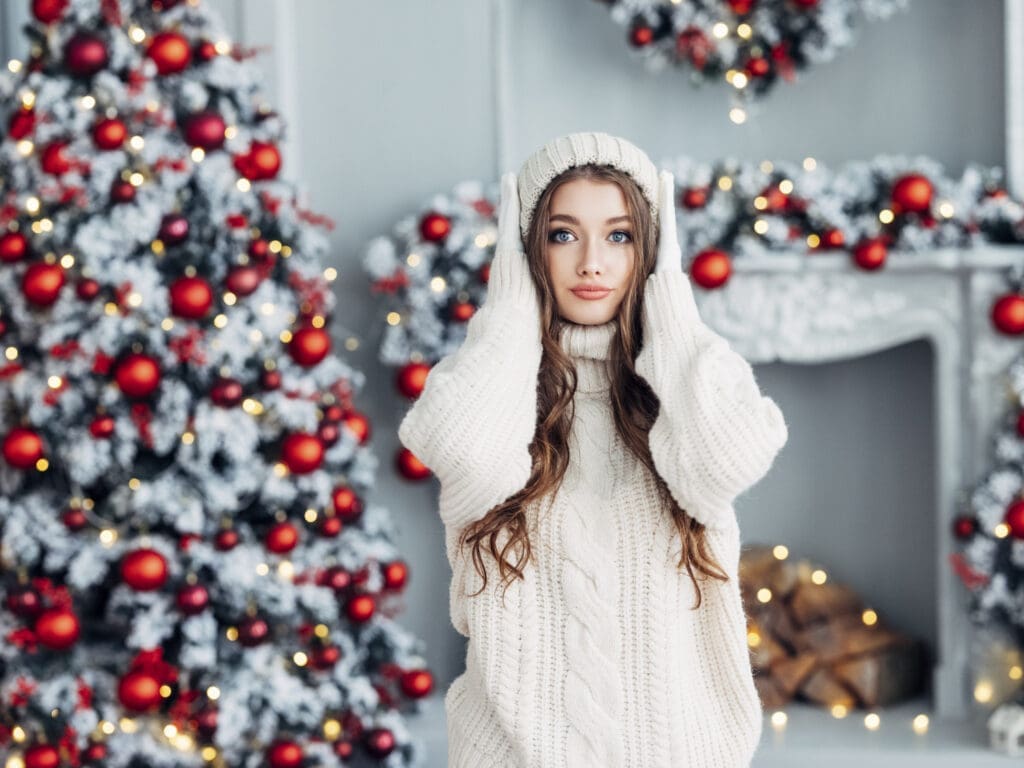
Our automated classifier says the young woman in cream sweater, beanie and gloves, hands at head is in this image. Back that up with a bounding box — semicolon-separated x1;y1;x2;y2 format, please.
398;132;787;768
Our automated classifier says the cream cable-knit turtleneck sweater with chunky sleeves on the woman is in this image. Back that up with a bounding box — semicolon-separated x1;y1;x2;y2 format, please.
398;270;787;768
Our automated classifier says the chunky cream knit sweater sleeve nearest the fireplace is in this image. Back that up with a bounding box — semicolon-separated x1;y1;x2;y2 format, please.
636;270;788;527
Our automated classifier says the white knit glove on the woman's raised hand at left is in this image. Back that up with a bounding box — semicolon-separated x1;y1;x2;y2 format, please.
484;172;540;313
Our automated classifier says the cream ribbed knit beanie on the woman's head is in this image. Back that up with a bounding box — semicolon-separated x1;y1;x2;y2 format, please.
518;131;657;241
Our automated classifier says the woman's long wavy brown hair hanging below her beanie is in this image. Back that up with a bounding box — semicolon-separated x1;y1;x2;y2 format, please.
459;165;729;609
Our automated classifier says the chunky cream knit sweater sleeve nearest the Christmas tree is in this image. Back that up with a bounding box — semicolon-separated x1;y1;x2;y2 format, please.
398;301;543;529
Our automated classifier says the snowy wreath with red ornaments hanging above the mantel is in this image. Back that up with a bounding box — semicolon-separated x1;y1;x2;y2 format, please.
597;0;908;115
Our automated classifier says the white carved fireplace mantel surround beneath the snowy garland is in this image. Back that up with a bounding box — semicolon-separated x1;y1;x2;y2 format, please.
694;246;1024;733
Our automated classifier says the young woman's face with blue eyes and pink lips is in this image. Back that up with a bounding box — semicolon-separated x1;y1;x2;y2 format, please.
545;178;635;326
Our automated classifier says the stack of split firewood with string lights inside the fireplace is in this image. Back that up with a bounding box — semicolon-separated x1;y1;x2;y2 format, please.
739;546;931;710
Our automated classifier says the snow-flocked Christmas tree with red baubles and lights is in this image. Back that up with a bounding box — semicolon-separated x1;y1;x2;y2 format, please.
0;0;432;768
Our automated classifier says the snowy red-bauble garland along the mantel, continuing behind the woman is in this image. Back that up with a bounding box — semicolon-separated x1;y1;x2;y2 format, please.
364;156;1024;378
